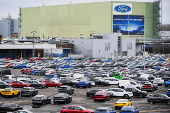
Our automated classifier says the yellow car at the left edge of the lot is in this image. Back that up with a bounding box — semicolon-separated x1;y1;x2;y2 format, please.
1;88;20;97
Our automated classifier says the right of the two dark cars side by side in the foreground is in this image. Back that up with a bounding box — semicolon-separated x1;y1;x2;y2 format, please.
53;93;72;104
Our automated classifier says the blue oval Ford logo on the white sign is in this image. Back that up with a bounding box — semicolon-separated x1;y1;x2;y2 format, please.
114;5;131;13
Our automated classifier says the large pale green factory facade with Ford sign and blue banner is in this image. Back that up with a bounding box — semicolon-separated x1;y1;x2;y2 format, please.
19;1;159;38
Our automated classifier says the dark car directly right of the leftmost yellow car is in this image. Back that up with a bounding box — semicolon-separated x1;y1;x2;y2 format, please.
21;87;38;97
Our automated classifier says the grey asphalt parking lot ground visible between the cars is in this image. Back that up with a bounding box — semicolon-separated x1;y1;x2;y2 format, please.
0;69;170;113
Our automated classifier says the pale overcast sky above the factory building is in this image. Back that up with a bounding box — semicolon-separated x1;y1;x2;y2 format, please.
0;0;170;24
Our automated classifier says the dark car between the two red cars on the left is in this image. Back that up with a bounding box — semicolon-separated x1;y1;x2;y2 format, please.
27;80;47;89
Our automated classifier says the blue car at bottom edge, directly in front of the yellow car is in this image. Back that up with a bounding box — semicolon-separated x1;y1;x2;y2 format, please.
119;106;139;113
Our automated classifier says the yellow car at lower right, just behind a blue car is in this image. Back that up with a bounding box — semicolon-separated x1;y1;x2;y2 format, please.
115;99;132;109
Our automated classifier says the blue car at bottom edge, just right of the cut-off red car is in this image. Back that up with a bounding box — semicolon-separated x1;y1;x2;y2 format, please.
94;107;116;113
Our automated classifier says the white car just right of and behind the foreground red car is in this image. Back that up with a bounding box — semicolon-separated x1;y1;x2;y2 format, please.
108;88;133;99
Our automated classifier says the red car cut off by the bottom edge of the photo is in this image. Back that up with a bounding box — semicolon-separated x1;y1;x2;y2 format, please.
60;106;94;113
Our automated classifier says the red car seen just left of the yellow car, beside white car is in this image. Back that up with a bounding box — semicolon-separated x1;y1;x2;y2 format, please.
94;91;110;102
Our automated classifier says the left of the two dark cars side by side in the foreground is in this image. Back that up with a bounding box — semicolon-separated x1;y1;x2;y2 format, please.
32;95;51;105
